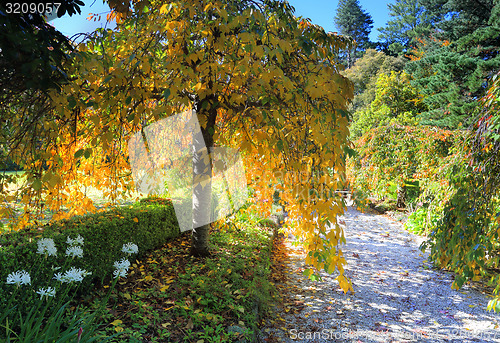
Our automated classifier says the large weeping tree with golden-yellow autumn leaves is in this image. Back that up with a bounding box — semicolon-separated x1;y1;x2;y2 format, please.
2;0;352;289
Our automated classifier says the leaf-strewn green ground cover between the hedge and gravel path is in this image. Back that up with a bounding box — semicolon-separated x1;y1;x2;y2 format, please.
75;213;274;343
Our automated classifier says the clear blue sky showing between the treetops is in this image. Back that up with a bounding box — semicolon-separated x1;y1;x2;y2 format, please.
51;0;394;41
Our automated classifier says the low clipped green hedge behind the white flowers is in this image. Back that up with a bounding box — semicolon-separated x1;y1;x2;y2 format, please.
0;198;180;311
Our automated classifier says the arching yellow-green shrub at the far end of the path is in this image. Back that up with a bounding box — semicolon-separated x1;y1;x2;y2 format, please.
347;125;463;206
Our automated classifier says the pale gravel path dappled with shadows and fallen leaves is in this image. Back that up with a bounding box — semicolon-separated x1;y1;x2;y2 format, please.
260;207;500;343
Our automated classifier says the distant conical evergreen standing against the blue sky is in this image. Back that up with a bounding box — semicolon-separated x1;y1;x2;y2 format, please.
333;0;373;68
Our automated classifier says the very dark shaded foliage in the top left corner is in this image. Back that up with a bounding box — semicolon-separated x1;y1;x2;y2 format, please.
0;0;84;97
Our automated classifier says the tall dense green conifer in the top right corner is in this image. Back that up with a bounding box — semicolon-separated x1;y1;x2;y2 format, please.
407;0;500;128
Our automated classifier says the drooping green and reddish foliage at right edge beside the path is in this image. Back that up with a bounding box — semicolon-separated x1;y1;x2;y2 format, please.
422;73;500;300
